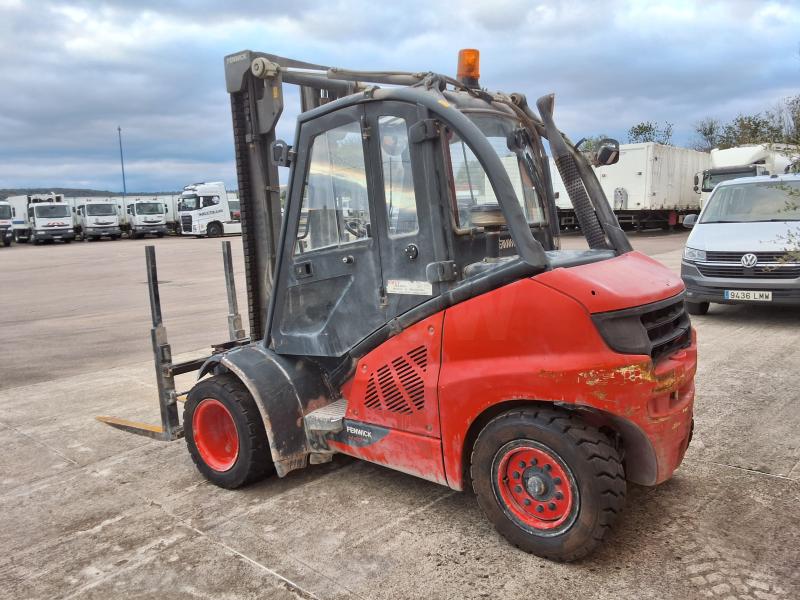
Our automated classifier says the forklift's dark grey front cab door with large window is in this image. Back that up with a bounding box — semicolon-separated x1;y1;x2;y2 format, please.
271;106;385;357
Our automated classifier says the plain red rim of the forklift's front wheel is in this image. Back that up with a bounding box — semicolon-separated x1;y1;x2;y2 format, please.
192;398;239;471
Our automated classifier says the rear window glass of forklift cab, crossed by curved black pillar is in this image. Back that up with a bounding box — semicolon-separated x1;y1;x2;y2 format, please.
449;112;546;228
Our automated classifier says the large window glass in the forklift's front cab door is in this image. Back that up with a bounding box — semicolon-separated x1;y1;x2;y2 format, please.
295;122;371;254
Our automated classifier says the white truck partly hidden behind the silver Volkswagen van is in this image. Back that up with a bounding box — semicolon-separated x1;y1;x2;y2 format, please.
694;144;800;208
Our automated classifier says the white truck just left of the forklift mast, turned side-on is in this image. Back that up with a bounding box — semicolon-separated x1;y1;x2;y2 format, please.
178;181;242;237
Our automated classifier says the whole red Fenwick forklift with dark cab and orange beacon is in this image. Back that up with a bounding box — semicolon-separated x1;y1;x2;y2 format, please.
103;50;697;561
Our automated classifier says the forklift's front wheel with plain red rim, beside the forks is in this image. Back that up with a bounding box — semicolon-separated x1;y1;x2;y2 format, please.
183;374;273;489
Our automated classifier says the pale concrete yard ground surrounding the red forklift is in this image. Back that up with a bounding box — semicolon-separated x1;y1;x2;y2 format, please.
0;234;800;600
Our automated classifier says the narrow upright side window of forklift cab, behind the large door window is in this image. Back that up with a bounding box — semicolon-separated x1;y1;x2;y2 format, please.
378;117;419;237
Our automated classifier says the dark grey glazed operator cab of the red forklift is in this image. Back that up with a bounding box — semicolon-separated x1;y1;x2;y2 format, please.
269;84;572;357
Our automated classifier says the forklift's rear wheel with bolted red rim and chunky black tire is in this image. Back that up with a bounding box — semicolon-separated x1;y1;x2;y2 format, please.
470;408;625;562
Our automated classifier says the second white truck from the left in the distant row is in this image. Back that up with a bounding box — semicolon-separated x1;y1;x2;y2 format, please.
6;193;75;244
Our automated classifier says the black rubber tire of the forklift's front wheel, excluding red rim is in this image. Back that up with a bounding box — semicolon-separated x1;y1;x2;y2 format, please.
183;374;274;489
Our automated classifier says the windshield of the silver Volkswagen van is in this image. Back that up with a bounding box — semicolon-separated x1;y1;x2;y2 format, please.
700;181;800;223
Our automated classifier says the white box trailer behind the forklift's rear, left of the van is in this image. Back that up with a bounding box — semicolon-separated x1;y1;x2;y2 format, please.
551;142;710;231
